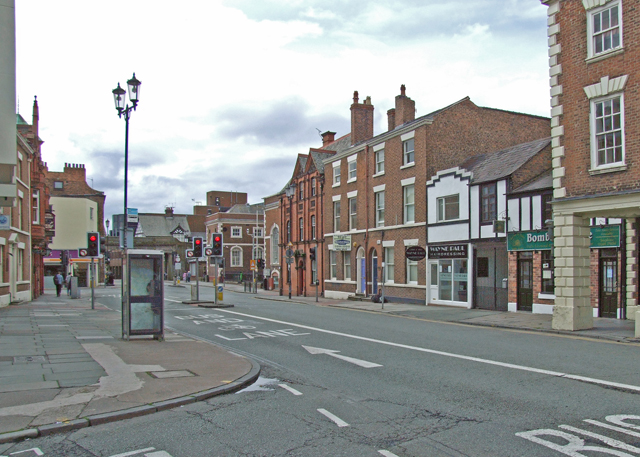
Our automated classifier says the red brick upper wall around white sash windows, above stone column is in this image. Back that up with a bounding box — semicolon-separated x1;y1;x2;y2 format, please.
556;0;640;197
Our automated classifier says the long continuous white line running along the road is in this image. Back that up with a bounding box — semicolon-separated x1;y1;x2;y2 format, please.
216;309;640;392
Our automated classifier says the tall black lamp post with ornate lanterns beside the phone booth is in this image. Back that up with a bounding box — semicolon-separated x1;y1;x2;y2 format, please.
112;73;141;339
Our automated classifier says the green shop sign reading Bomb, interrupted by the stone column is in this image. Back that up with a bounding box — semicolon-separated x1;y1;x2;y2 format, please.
507;225;620;251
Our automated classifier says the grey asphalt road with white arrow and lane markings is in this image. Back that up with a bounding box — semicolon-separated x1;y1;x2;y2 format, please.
0;287;640;457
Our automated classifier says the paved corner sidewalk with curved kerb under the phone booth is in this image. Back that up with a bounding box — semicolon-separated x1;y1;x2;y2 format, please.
0;290;260;443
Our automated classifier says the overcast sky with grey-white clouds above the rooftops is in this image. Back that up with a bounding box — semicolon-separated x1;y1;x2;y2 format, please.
16;0;549;225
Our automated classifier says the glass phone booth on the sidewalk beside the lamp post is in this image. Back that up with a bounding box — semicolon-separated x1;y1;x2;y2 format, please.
122;249;164;340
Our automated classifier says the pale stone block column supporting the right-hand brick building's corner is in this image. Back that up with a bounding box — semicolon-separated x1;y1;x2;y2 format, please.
551;213;593;331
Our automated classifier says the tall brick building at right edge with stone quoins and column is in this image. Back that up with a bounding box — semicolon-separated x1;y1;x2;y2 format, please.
542;0;640;336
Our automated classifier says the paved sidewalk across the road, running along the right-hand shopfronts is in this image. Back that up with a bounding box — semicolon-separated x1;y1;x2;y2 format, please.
219;284;640;343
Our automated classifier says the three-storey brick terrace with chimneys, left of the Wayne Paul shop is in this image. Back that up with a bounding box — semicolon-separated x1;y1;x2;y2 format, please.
324;85;549;303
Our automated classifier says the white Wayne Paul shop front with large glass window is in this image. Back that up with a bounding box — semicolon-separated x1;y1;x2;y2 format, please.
427;244;472;308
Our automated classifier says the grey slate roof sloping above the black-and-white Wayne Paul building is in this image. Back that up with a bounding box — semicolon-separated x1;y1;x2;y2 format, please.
460;138;551;184
